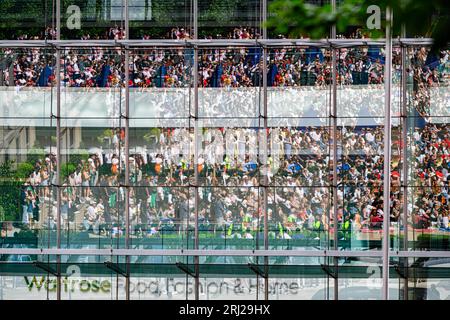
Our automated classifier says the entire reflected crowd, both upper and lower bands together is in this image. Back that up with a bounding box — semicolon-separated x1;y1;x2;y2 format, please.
0;42;444;242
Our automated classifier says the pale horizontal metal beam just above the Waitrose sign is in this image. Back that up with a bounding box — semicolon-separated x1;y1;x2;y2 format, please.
0;248;450;258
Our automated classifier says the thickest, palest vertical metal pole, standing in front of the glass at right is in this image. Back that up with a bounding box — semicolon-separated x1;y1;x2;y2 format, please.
382;6;392;300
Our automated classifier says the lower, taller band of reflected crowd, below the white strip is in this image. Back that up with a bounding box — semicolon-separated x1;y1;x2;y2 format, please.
14;120;450;239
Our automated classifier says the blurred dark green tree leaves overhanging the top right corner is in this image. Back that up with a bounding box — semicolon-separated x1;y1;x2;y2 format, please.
266;0;450;49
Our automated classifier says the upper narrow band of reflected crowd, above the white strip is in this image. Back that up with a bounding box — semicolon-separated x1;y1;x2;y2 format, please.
0;48;448;93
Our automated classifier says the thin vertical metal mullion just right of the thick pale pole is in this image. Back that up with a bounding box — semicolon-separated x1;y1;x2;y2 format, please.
400;25;408;300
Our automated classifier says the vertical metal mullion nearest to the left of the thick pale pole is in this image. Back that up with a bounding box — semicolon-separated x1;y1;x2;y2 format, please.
330;0;339;300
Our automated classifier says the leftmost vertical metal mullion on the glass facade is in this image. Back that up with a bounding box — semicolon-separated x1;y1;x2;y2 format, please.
55;0;61;300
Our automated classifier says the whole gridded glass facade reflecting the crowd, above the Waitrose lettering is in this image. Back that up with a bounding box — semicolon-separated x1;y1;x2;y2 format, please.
0;0;450;300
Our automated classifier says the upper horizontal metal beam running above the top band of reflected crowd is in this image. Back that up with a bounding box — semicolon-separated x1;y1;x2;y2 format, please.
0;38;433;48
